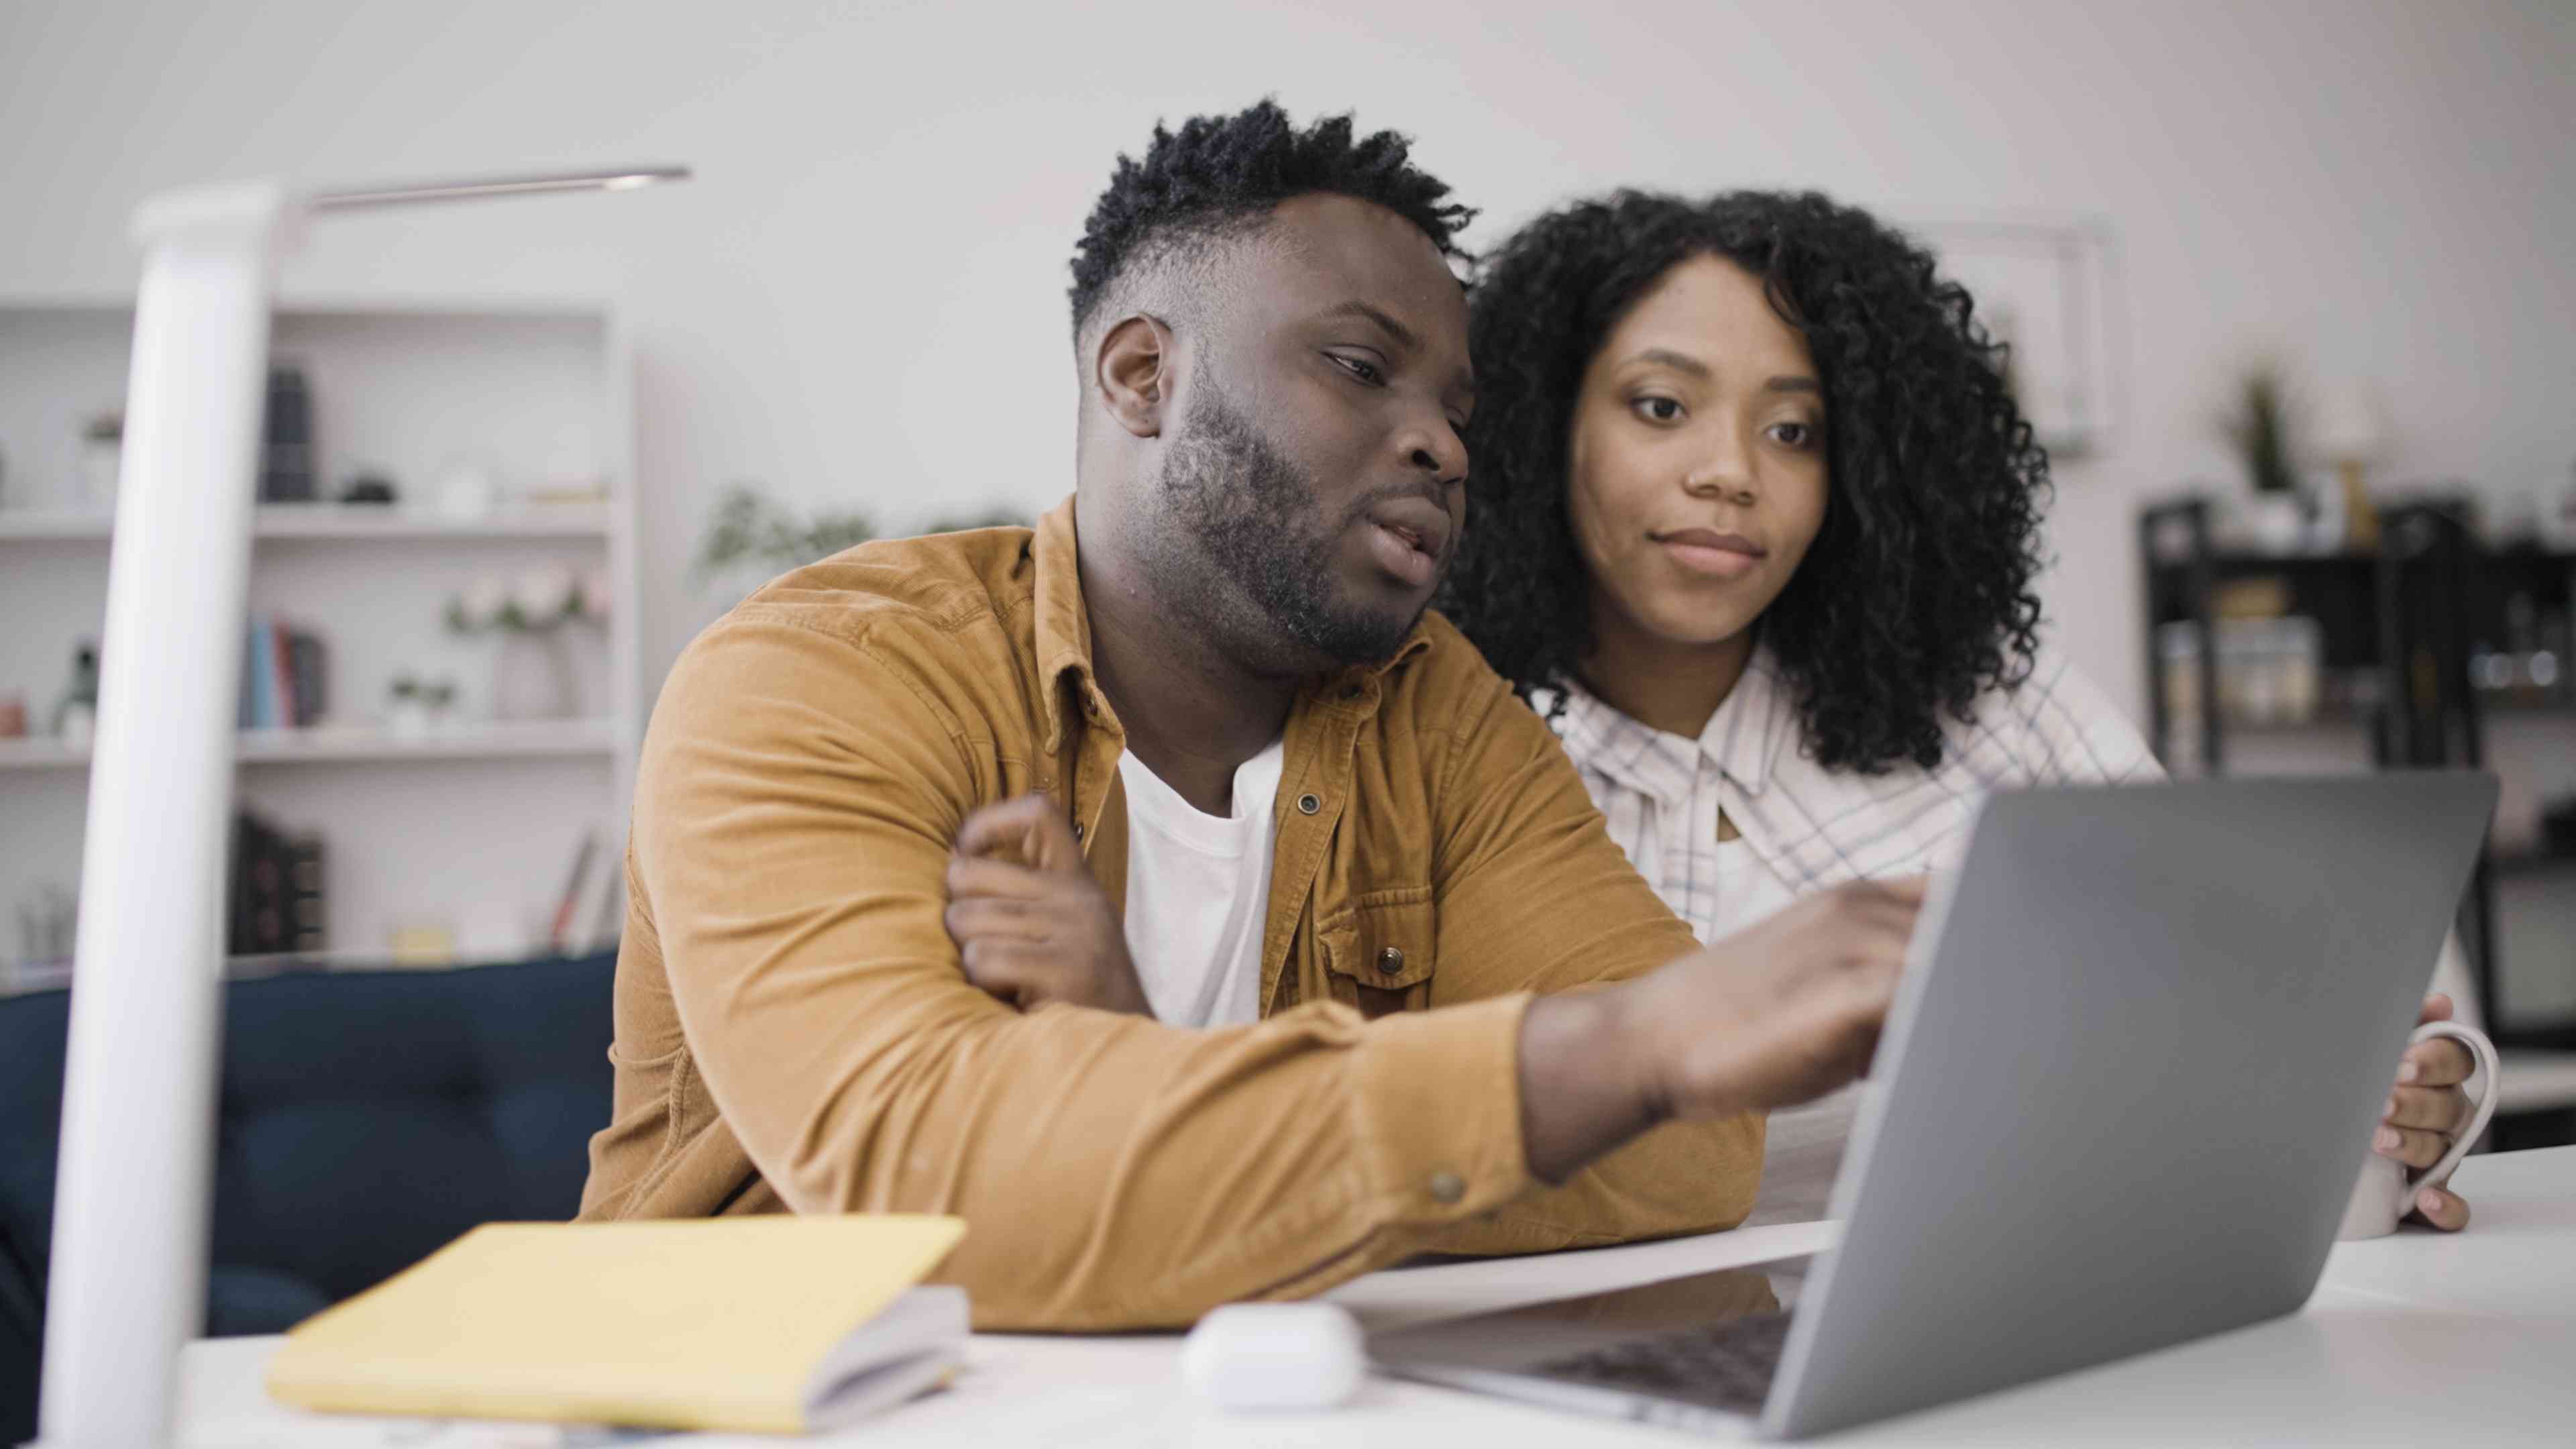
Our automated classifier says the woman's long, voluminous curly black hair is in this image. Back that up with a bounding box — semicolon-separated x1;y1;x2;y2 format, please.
1440;191;2051;773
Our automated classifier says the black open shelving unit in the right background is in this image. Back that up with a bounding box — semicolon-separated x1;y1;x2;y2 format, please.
2138;490;2576;1147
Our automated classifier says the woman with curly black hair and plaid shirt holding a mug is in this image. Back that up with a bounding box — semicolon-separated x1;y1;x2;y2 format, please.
1440;191;2468;1230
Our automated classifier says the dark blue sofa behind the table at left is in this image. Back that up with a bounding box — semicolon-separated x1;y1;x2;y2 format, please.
0;954;616;1444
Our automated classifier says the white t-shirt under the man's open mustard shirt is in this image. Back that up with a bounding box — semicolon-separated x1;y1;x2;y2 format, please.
1118;740;1285;1026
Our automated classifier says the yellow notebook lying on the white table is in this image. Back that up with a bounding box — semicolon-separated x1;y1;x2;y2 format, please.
268;1214;966;1434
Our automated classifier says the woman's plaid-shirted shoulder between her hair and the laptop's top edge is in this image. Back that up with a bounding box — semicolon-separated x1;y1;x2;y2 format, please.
1940;642;2164;789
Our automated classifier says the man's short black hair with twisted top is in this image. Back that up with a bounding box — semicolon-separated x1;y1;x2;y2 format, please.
1071;101;1476;337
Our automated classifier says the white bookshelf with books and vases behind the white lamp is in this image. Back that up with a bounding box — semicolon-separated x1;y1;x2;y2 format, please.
0;294;641;975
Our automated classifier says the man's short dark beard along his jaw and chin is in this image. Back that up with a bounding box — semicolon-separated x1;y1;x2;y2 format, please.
1154;376;1422;673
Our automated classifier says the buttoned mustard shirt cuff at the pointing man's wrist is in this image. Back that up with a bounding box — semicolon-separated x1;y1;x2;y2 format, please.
1352;993;1536;1212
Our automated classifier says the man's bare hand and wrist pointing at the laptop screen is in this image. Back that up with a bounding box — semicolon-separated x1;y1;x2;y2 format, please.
1520;877;1924;1181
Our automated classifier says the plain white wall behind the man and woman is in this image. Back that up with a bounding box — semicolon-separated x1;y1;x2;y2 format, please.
0;0;2576;722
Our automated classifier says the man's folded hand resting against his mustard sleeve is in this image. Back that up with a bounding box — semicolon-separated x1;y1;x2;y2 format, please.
948;794;1154;1016
